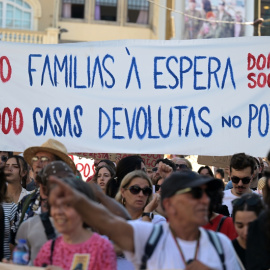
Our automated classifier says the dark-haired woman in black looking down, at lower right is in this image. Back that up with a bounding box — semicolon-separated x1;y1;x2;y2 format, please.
232;193;264;268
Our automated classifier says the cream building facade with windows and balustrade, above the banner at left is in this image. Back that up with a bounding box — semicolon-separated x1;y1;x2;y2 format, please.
0;0;165;43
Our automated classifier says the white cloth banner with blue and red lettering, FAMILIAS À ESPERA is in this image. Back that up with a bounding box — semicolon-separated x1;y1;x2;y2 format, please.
0;37;270;156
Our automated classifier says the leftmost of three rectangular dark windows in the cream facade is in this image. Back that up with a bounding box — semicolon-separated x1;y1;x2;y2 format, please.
62;0;85;19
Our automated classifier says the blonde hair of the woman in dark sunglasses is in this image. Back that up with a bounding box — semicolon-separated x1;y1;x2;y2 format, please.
115;170;153;205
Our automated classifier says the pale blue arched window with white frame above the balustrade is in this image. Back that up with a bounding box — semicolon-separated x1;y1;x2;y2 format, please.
0;0;33;30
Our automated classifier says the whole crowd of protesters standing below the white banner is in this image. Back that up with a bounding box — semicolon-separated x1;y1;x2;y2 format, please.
0;139;270;270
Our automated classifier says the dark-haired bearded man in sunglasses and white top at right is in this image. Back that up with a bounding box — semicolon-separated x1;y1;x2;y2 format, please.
223;153;255;215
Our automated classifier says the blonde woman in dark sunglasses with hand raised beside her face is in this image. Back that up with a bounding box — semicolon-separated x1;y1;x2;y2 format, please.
115;170;166;223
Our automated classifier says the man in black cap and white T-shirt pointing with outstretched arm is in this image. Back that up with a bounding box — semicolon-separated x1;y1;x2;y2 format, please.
49;171;240;270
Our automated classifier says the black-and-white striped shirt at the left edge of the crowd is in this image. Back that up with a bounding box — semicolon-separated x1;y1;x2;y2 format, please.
2;202;17;259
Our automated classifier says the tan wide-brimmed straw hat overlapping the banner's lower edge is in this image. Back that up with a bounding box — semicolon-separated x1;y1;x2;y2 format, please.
23;139;76;173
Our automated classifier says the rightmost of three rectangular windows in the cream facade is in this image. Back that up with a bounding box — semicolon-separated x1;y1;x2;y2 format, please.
127;0;149;24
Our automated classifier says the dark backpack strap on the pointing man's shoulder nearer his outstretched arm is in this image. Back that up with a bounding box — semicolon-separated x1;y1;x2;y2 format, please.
140;224;163;270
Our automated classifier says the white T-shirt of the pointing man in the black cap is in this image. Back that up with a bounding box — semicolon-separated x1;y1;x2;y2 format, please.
124;221;240;270
